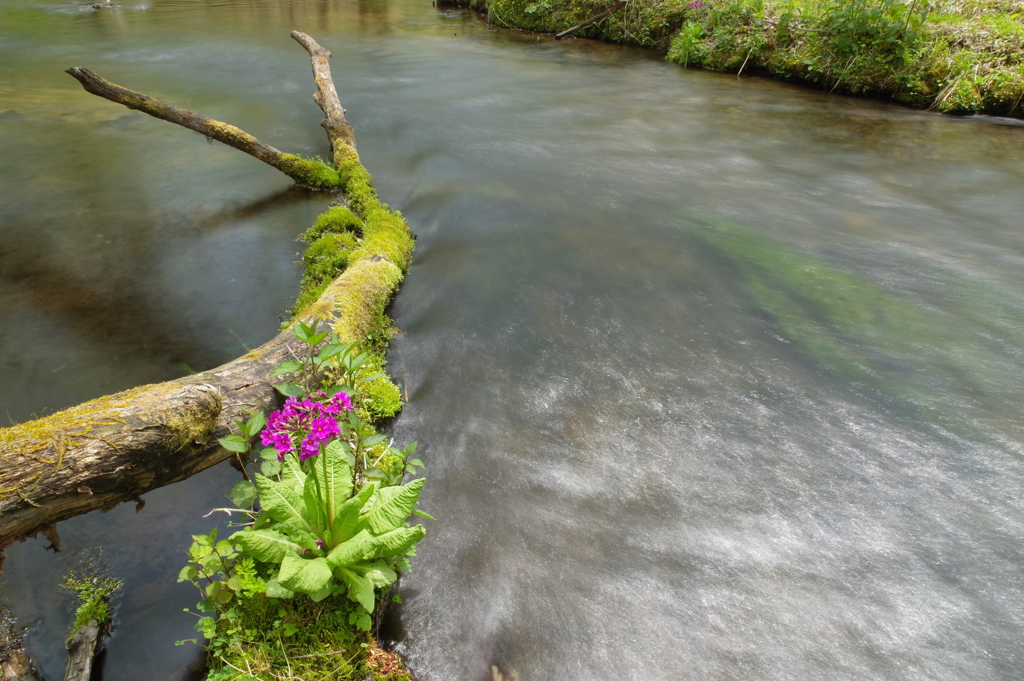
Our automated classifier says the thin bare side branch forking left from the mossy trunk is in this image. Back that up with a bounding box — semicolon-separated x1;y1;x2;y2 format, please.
66;67;340;189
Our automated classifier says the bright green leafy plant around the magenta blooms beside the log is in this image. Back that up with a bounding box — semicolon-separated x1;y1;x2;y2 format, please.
178;323;431;645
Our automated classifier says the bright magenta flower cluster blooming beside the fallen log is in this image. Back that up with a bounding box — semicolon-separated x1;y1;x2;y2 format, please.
260;391;353;461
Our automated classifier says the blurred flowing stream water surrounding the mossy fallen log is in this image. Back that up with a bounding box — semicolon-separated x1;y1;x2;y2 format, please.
0;0;1024;681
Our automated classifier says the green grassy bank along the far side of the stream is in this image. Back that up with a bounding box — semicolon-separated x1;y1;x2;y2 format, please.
456;0;1024;118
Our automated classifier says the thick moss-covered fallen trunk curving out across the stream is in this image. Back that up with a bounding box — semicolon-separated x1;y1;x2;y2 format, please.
0;32;413;565
